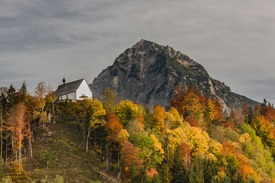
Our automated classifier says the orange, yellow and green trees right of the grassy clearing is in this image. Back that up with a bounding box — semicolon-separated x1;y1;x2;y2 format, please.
55;87;275;183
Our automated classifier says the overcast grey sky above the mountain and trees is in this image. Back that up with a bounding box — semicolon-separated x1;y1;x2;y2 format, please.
0;0;275;103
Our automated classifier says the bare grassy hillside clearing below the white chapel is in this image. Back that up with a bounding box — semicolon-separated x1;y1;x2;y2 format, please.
22;124;115;182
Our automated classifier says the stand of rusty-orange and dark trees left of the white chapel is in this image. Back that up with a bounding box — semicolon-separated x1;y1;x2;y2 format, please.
0;82;54;177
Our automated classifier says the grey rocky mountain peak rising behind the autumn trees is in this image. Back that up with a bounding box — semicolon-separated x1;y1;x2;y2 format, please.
91;40;257;111
